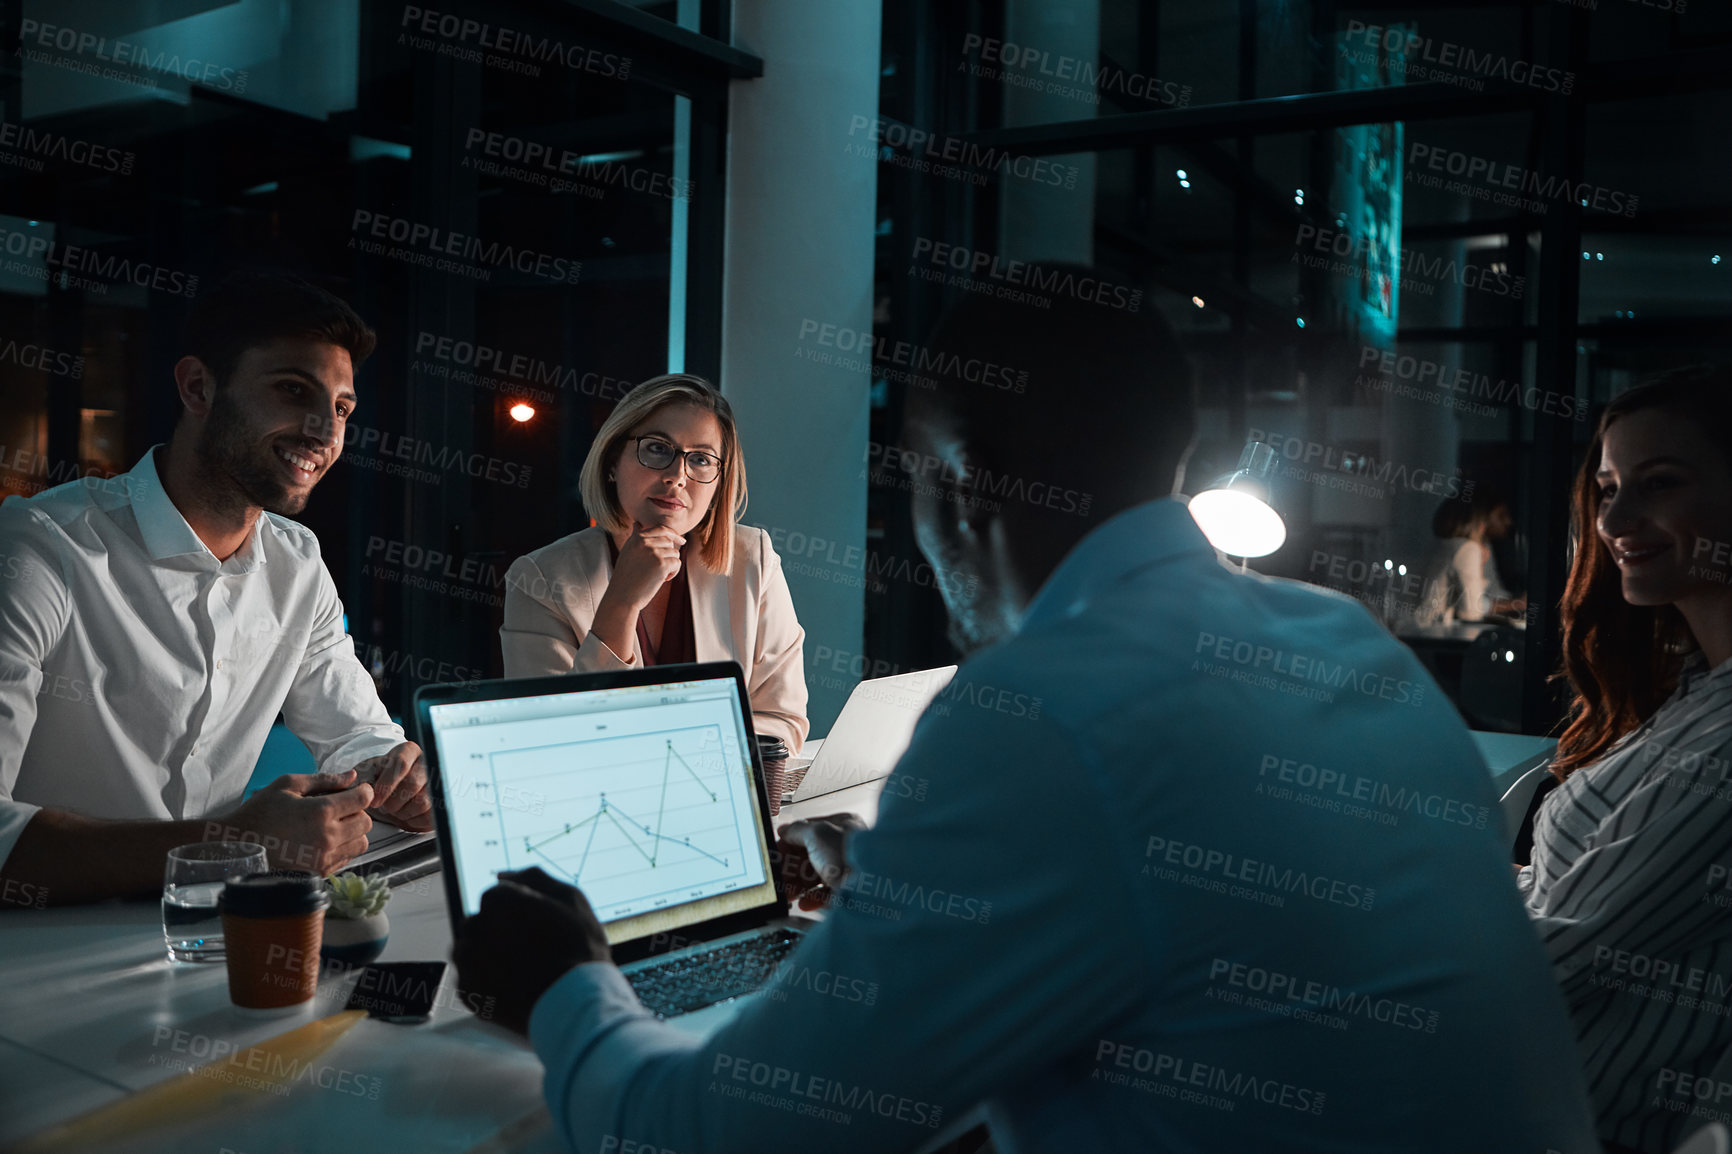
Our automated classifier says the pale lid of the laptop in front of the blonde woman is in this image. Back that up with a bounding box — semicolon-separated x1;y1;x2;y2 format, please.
788;665;956;802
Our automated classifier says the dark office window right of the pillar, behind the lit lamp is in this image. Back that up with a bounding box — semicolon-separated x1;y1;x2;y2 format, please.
868;0;1732;731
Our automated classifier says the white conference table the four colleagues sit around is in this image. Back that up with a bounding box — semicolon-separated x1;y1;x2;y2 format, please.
0;735;1554;1154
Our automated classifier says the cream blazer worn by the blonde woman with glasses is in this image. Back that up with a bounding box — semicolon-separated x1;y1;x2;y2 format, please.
499;525;809;754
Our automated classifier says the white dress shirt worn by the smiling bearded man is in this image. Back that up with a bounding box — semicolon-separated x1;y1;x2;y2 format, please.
0;449;404;861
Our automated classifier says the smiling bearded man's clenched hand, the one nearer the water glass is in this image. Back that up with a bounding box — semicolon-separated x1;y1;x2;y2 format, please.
227;769;372;873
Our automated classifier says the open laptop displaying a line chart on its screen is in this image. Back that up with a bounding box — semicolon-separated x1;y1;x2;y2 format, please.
416;662;800;1029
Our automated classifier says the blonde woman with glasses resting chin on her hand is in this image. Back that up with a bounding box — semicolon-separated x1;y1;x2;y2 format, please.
499;373;807;752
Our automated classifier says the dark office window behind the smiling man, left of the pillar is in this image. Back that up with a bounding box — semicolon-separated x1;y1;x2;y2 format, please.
0;0;750;710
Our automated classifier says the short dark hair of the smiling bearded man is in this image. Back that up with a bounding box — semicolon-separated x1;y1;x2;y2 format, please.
185;269;378;385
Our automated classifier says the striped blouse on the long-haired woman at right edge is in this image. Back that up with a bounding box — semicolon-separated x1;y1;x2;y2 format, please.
1517;655;1732;1154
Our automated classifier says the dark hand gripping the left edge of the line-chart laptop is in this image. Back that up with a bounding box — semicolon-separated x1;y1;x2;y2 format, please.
450;866;613;1034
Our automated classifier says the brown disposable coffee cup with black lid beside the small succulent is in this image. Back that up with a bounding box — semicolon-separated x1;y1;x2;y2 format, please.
217;870;331;1010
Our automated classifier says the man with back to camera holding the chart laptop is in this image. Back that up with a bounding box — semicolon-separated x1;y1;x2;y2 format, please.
454;267;1599;1154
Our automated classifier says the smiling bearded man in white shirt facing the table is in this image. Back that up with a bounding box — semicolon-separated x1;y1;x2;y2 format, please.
0;272;431;904
